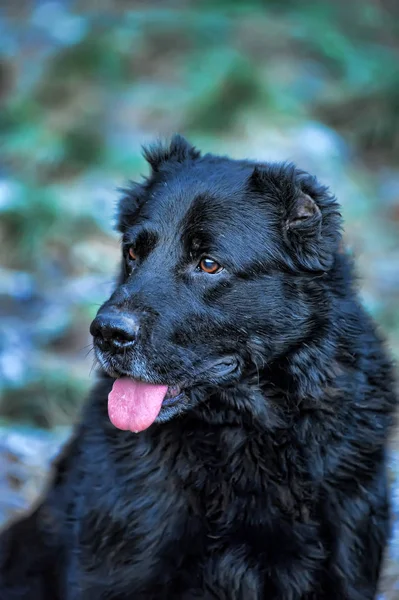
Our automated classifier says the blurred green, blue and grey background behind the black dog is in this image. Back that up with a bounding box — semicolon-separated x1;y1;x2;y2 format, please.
0;0;399;599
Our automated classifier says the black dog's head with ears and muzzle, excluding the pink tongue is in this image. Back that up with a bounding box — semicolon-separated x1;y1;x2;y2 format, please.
91;137;339;420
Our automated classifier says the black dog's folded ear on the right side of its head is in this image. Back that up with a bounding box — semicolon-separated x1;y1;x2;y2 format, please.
250;164;341;272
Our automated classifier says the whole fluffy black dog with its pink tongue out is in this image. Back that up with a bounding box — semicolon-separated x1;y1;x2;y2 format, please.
0;136;396;600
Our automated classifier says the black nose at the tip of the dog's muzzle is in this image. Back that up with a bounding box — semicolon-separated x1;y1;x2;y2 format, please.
90;312;139;348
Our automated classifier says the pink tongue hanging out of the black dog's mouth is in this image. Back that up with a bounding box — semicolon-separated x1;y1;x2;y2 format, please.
108;377;168;433
